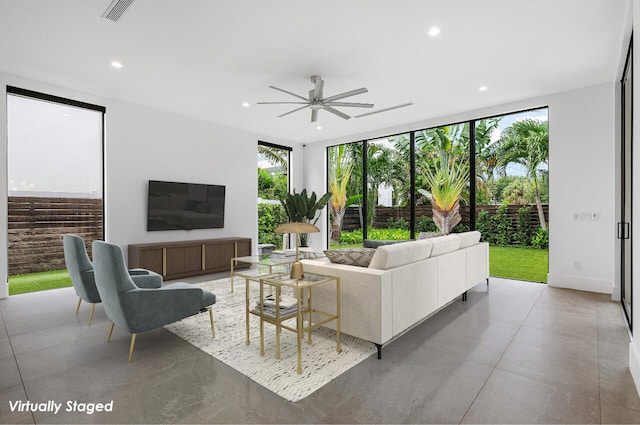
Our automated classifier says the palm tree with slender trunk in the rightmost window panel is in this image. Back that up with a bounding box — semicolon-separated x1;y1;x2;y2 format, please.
495;118;549;230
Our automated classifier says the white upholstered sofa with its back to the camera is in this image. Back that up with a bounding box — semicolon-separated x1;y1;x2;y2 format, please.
303;231;489;358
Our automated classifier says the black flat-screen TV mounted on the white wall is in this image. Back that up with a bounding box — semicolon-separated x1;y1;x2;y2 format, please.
147;180;225;231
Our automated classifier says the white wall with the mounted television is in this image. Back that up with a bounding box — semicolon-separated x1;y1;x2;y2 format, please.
0;74;303;298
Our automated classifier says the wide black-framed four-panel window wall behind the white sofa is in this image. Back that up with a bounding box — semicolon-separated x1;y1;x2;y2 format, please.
327;108;549;282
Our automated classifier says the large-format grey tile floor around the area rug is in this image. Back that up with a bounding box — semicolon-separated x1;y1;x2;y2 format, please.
0;275;640;423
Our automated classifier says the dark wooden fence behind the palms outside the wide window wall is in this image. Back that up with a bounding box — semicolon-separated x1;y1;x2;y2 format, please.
342;204;549;230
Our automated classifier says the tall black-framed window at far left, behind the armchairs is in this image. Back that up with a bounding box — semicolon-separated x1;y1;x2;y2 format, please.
7;87;105;294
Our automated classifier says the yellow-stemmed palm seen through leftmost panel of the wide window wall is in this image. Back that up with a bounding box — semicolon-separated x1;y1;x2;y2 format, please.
328;145;361;242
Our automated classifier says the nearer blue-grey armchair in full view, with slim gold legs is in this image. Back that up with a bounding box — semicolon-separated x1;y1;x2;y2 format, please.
93;241;216;363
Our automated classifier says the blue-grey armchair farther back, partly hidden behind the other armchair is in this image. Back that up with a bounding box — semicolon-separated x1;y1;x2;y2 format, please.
62;234;162;326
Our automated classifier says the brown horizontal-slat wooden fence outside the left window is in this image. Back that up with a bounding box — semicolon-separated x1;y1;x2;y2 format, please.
8;196;103;275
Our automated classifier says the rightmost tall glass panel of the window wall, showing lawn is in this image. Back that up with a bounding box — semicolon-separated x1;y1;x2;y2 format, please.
474;108;549;282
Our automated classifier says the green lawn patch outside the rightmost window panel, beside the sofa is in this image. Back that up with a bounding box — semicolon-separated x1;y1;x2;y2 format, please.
489;246;549;283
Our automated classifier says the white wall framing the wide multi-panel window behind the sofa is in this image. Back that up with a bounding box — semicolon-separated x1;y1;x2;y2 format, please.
304;83;617;294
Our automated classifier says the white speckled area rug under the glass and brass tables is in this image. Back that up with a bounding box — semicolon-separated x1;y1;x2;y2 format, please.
166;279;376;401
